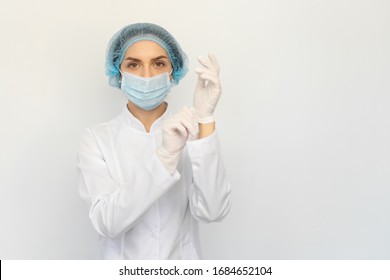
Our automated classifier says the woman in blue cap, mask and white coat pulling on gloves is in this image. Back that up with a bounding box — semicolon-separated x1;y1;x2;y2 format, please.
77;23;231;259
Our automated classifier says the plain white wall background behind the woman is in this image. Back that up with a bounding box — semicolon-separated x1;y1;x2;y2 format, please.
0;0;390;259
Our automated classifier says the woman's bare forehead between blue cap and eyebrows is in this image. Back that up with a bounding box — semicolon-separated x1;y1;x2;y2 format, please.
124;40;168;59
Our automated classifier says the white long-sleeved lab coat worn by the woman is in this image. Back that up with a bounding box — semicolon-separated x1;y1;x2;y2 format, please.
78;107;231;259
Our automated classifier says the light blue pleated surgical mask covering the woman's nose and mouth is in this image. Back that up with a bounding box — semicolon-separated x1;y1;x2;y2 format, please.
121;72;171;111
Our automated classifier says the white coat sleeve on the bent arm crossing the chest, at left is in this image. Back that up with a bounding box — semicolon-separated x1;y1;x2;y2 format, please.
77;129;180;238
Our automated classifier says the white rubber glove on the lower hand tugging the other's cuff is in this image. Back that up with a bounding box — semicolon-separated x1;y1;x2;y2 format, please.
156;107;196;175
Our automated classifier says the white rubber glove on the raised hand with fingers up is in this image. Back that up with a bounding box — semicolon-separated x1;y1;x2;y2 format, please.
193;54;222;123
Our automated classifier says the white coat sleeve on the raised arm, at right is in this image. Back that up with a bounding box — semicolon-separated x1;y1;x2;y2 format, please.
187;132;231;223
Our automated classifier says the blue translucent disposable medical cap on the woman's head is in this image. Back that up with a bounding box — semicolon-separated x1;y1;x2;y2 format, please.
106;23;188;88
